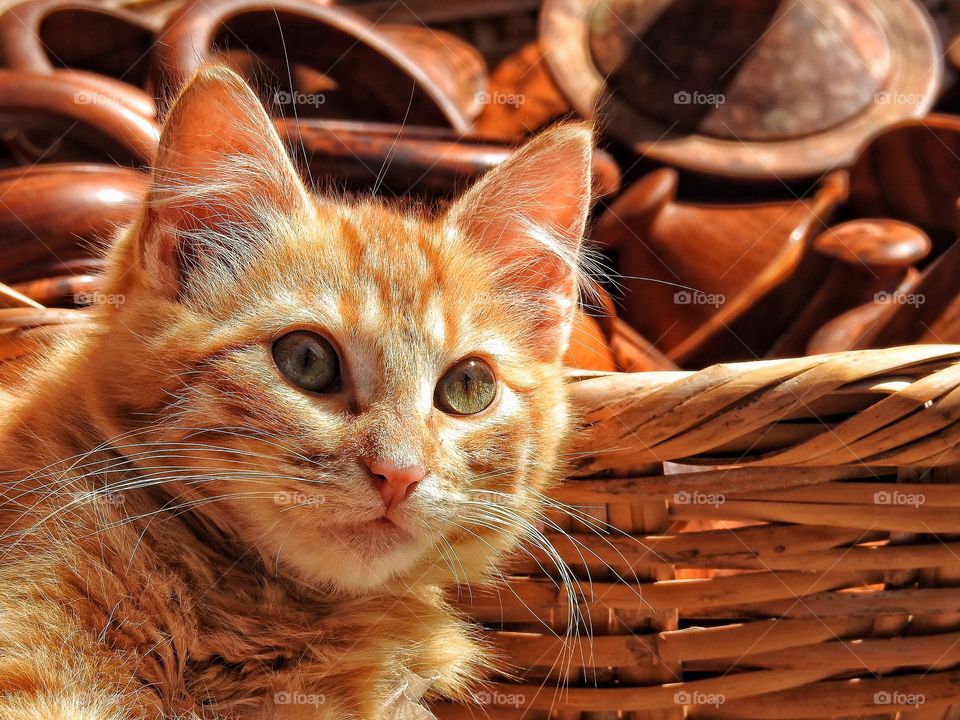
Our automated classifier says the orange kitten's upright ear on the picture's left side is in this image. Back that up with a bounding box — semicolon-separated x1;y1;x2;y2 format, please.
136;65;310;297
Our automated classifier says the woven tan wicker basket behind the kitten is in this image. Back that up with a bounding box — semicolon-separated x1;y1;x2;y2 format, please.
0;308;960;720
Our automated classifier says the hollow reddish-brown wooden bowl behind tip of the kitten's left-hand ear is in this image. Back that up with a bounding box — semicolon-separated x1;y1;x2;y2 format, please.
153;0;486;132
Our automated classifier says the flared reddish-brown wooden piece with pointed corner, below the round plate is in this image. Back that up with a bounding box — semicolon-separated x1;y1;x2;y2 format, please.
593;169;846;365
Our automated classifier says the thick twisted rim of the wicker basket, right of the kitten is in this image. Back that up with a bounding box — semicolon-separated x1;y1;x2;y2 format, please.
572;345;960;476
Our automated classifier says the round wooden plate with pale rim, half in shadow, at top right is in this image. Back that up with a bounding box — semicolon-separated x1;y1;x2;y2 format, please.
540;0;943;179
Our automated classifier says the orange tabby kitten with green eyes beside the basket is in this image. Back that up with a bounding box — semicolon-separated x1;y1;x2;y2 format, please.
0;66;591;720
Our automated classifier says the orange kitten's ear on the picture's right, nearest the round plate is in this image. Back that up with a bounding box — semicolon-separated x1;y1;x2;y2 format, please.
448;124;593;360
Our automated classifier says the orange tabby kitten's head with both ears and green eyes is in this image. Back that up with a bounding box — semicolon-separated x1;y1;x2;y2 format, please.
96;67;591;592
